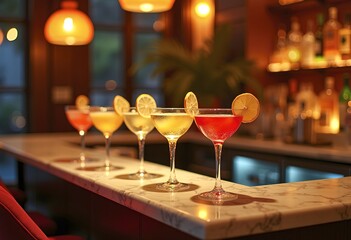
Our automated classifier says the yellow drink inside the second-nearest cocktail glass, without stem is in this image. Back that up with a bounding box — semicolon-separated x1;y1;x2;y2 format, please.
151;112;193;140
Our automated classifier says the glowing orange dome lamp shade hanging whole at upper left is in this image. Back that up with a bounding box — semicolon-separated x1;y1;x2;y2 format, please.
44;1;94;45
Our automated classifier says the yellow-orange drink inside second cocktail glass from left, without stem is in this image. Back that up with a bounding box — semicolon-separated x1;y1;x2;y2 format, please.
90;111;123;136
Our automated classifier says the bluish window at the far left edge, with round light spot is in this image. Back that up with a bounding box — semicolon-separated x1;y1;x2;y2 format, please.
0;0;27;182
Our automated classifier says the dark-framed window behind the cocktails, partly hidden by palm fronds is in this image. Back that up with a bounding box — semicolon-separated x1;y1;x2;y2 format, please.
90;0;163;105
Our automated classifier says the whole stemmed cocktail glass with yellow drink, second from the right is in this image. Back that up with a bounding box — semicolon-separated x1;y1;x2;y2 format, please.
151;108;193;191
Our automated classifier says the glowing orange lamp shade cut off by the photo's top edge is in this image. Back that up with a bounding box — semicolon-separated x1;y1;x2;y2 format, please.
119;0;174;13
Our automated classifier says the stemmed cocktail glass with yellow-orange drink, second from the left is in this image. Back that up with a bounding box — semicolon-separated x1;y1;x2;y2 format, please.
90;107;123;171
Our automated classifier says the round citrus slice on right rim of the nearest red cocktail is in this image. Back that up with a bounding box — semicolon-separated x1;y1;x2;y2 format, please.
232;93;260;123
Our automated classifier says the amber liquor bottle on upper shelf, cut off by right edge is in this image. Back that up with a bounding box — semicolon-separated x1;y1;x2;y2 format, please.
339;14;351;60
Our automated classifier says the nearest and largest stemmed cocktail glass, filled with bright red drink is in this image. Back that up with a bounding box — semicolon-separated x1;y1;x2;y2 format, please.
195;108;243;203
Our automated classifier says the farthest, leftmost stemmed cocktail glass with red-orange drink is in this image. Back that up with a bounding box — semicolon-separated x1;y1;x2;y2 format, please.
65;105;96;165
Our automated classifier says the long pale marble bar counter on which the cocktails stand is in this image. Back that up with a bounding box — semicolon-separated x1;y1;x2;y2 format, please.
0;133;351;239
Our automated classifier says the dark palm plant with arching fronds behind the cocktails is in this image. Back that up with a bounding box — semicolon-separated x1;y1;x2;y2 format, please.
134;25;260;107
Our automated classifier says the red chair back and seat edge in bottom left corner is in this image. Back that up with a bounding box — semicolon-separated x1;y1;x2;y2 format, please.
0;186;84;240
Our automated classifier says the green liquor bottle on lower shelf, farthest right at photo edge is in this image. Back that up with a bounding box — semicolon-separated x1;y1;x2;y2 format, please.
339;73;351;131
